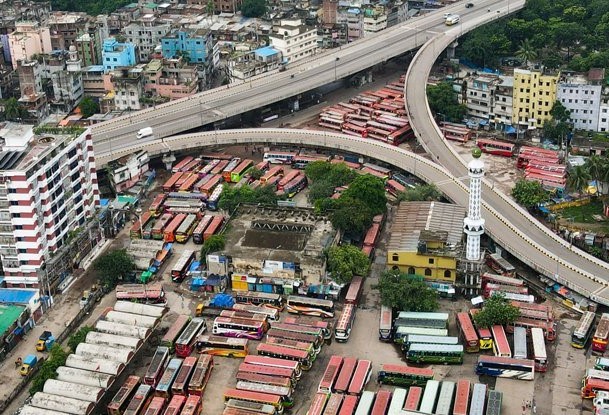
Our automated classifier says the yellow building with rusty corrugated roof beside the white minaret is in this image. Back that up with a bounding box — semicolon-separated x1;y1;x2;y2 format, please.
387;202;465;283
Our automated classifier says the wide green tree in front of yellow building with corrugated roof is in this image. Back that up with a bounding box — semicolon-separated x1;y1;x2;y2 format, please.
374;270;439;311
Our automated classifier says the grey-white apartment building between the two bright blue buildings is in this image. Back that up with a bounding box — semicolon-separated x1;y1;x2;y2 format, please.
123;14;171;62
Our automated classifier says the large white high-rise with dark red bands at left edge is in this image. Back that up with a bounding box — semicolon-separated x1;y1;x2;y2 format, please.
0;123;99;288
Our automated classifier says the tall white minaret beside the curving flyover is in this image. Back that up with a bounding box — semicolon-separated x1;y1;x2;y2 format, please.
463;147;484;261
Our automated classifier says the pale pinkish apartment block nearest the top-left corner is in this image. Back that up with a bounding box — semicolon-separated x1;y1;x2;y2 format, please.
8;22;53;69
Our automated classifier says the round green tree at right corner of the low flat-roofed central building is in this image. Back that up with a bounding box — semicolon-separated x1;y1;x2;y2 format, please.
326;245;370;284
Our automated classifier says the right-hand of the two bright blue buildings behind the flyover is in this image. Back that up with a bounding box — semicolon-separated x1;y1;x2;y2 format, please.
161;30;213;64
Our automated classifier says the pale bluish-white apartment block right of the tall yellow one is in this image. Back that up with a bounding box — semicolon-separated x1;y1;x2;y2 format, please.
557;73;602;131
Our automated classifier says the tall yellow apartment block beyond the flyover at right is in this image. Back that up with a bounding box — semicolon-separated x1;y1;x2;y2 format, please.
512;69;559;129
